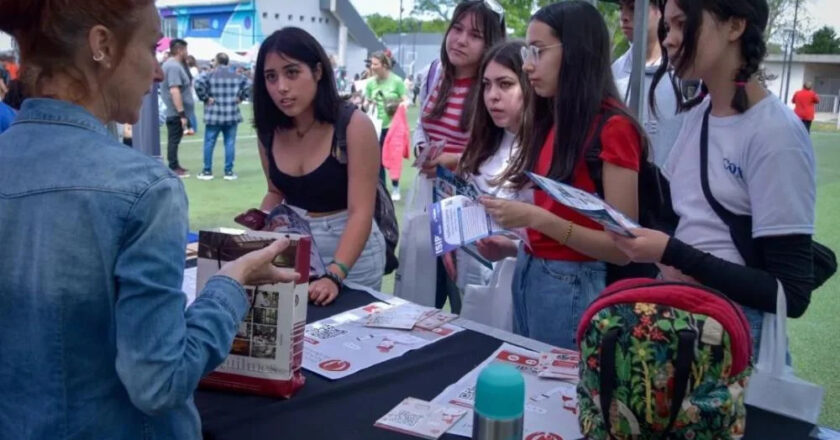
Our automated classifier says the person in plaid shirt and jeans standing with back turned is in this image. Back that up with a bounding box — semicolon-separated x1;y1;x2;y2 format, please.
195;53;250;180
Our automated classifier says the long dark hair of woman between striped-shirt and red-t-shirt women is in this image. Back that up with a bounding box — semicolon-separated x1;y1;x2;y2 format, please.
458;41;529;175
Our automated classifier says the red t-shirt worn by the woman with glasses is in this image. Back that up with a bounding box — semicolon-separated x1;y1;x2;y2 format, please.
526;107;642;261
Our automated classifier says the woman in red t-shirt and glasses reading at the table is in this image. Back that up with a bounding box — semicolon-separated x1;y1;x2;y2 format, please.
483;2;647;348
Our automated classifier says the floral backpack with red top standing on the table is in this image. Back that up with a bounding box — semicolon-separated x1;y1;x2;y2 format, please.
577;279;752;440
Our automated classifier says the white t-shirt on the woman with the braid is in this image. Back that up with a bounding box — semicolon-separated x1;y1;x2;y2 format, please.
663;93;816;264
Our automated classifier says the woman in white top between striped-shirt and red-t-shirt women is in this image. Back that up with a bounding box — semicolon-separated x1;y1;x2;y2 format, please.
456;41;528;293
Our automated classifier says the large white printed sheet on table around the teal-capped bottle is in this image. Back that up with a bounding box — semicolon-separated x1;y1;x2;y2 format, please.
432;343;583;440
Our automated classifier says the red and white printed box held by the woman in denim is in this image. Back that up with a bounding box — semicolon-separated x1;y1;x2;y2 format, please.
196;228;312;398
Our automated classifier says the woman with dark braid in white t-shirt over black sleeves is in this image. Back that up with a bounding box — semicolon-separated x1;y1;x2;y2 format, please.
614;0;816;353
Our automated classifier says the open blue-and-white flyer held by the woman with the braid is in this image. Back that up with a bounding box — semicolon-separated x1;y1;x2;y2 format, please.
527;173;641;238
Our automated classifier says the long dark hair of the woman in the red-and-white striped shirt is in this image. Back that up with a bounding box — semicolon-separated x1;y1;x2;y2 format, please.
428;0;505;131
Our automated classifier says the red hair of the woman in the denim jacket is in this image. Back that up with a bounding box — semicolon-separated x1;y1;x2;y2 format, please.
0;0;154;98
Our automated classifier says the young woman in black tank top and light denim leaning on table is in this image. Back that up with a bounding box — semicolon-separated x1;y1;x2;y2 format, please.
249;28;385;305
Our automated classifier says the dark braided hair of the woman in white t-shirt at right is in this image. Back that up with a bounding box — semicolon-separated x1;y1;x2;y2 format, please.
650;0;770;113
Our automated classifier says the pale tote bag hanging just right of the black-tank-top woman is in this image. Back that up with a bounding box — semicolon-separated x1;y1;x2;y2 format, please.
394;176;437;307
